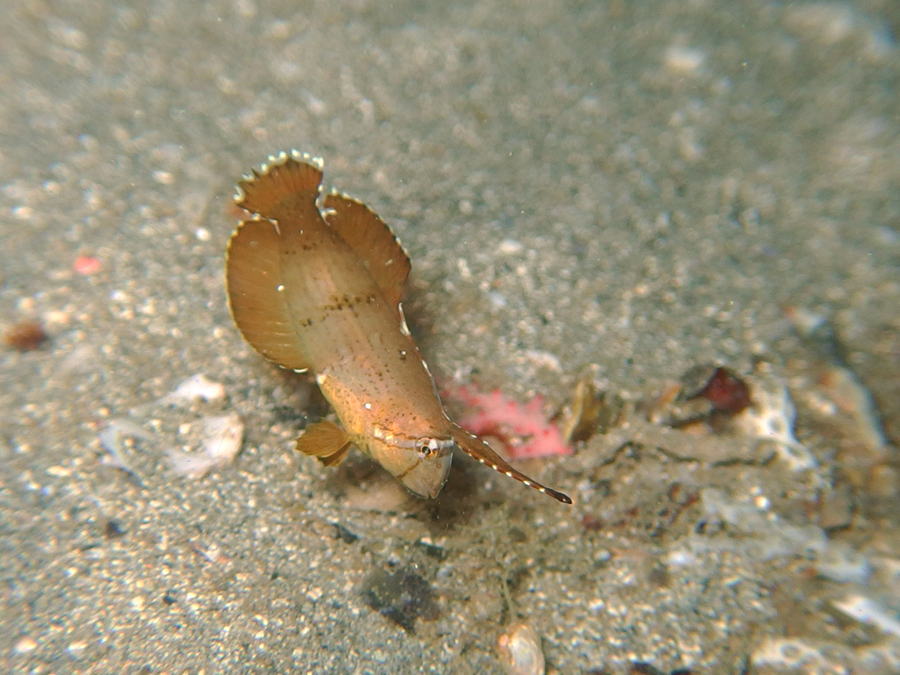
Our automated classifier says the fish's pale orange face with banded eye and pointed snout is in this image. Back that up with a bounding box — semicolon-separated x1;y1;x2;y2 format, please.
368;436;455;499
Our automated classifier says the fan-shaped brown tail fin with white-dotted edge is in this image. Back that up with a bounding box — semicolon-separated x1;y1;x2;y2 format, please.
234;150;322;219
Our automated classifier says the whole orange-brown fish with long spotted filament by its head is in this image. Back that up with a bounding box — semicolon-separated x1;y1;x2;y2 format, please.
226;151;572;504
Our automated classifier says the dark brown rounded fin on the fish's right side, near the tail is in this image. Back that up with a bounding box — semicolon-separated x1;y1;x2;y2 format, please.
325;192;410;307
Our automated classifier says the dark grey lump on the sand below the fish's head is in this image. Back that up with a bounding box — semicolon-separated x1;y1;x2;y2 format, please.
362;568;440;633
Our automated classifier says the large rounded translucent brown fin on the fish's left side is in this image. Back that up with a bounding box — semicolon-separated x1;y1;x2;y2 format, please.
225;219;309;370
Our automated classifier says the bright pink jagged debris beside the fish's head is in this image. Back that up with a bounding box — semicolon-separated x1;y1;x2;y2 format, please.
449;386;572;459
